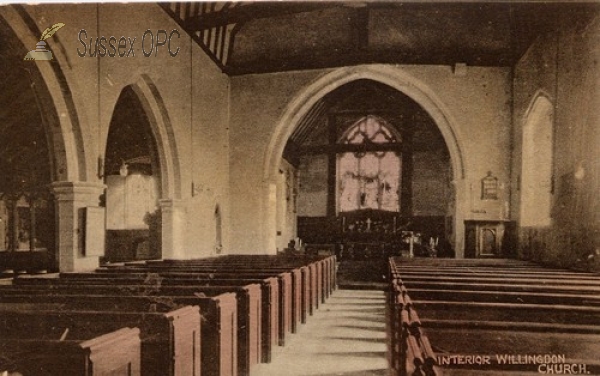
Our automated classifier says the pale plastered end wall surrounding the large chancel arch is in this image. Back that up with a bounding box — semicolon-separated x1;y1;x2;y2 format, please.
230;66;511;254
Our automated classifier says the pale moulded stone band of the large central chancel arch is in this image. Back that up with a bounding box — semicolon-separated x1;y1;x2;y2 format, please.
262;65;467;257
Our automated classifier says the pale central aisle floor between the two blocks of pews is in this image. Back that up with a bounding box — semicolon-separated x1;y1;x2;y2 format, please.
252;290;388;376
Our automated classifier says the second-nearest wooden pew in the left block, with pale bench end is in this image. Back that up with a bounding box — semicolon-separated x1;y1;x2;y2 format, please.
0;303;200;376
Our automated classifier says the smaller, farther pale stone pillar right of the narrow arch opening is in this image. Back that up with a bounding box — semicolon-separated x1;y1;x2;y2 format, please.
159;199;190;259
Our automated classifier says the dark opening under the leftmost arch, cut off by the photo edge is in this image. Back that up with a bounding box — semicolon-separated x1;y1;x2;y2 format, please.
0;17;57;272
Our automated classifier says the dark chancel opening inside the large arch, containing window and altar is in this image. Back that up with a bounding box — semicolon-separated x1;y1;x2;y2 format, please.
288;79;455;259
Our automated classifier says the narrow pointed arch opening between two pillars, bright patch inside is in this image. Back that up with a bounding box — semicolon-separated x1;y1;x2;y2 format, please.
103;86;162;262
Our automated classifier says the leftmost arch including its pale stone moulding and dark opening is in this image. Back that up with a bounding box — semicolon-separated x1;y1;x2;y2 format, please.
0;5;87;270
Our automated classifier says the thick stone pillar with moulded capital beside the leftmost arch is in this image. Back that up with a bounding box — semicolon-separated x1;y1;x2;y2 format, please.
52;181;106;272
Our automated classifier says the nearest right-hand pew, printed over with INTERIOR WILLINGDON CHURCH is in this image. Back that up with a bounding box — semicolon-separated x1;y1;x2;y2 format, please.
423;321;600;376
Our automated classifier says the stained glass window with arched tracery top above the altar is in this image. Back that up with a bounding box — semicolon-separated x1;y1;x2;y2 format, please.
337;116;402;212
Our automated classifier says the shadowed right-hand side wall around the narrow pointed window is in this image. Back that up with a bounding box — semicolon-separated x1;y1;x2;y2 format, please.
512;12;600;270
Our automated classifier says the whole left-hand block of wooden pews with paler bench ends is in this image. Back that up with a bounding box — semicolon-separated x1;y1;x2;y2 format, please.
0;255;336;376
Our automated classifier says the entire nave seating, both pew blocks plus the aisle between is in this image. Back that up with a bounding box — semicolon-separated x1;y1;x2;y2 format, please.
0;255;600;376
